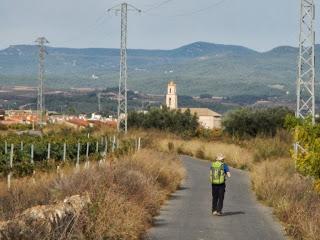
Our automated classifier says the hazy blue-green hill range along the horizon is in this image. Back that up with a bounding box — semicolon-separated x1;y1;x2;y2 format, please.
0;42;320;98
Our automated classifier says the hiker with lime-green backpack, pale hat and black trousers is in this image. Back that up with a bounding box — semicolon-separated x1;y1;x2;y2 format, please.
210;153;231;216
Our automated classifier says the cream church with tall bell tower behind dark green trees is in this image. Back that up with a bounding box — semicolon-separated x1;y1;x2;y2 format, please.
166;81;222;129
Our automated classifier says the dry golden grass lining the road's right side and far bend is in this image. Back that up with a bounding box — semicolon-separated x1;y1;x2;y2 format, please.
156;133;320;240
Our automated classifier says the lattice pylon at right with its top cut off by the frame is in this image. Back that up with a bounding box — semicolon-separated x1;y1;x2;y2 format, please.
296;0;315;123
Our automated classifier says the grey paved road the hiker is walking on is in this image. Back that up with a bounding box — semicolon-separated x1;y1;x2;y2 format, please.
146;156;285;240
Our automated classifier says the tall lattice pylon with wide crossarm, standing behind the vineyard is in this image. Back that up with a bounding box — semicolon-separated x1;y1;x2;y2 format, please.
108;3;141;134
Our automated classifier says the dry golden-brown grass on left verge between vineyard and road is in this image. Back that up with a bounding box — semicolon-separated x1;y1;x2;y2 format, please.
0;150;184;240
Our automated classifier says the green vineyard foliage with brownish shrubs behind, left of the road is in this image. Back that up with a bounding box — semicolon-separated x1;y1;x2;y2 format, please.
0;125;136;177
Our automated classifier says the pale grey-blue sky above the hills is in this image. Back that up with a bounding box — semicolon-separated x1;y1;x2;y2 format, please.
0;0;320;51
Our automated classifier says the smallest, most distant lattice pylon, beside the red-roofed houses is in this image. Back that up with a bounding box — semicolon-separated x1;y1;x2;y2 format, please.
36;37;49;124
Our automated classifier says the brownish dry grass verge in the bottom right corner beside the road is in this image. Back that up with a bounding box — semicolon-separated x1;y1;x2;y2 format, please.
251;158;320;240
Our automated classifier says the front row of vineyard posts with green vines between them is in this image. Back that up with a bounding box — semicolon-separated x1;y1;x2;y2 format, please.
0;136;141;189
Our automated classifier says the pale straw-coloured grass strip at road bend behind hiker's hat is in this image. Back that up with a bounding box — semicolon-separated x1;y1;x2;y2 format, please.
157;139;253;169
